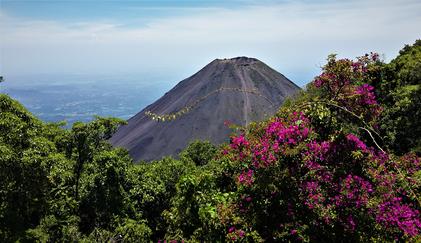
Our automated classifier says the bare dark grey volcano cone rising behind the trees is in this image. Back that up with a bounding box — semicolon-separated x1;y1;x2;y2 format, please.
110;57;300;161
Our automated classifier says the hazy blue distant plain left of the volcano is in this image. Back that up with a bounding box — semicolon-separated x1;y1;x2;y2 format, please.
0;74;172;127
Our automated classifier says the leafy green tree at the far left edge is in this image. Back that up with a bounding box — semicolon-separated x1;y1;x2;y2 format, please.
0;94;57;241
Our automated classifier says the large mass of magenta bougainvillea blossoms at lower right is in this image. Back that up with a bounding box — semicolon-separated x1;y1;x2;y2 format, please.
226;124;421;239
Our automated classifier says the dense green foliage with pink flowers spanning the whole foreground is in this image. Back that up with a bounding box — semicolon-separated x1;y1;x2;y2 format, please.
0;41;421;242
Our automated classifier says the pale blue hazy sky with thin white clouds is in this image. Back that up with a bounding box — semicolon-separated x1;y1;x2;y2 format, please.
0;0;421;85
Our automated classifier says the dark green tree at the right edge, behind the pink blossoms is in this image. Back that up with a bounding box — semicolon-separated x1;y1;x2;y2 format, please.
371;40;421;155
